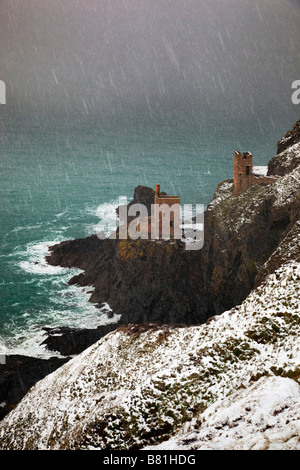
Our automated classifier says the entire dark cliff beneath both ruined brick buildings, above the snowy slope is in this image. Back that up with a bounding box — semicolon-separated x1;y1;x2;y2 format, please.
47;123;300;346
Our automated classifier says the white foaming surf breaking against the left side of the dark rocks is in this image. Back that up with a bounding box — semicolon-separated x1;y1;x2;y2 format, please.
0;200;125;357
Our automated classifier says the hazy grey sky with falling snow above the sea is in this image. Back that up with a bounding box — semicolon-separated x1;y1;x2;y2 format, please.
0;0;300;125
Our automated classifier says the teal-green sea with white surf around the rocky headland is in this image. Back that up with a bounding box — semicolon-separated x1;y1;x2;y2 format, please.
0;115;296;357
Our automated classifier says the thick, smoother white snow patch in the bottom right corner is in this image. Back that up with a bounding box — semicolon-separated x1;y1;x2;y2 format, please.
146;377;300;450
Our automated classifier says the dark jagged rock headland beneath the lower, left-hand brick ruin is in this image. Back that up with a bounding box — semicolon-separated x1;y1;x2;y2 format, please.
47;237;207;324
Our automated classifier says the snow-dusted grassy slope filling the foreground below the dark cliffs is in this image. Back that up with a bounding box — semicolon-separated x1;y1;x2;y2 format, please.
0;262;300;449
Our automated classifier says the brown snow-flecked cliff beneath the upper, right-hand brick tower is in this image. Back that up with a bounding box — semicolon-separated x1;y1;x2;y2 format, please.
201;144;300;313
